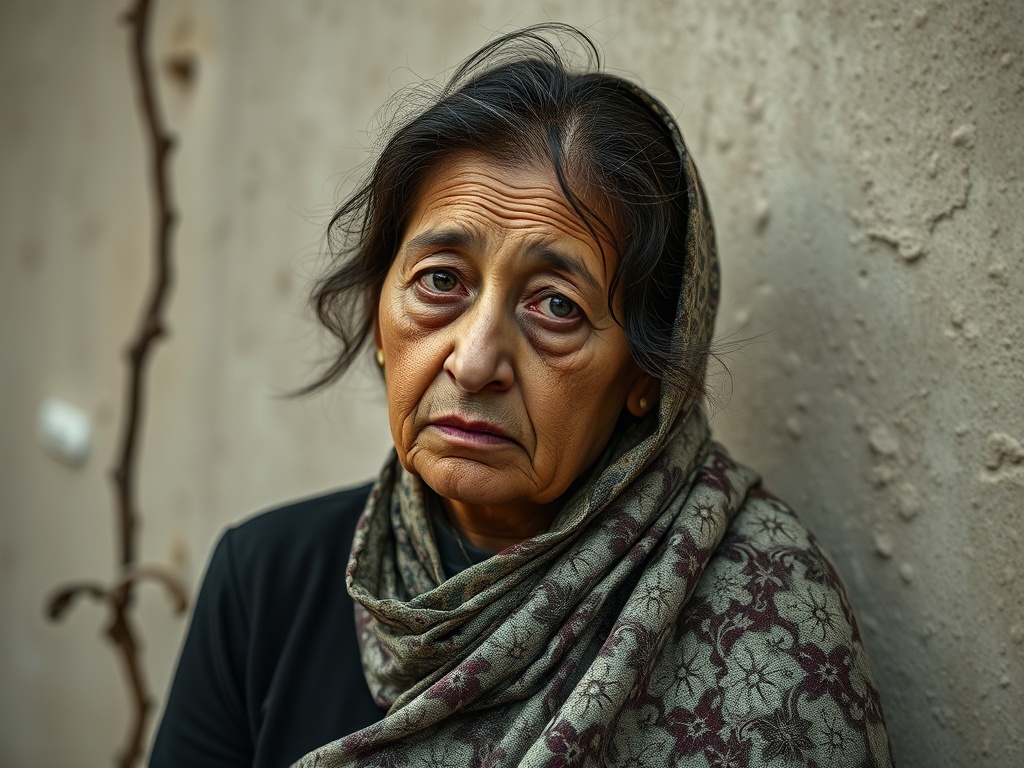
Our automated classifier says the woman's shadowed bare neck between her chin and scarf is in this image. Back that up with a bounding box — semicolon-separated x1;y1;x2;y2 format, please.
441;498;560;552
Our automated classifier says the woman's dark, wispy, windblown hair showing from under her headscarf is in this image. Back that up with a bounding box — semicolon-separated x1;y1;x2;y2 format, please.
302;24;708;393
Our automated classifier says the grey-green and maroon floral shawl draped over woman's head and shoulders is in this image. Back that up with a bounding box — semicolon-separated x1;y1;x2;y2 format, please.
296;91;891;768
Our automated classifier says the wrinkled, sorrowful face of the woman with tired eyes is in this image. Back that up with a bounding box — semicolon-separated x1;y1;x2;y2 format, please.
377;155;653;524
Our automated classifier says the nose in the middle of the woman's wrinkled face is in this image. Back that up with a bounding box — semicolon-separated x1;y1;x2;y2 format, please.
444;296;515;392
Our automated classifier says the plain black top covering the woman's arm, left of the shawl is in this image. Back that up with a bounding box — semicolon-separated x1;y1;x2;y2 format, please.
150;485;384;768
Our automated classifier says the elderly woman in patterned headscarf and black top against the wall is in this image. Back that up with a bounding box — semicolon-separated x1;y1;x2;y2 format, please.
152;26;891;768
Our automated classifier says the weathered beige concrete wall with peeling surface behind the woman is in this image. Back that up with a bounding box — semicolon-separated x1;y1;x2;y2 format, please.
0;0;1024;768
